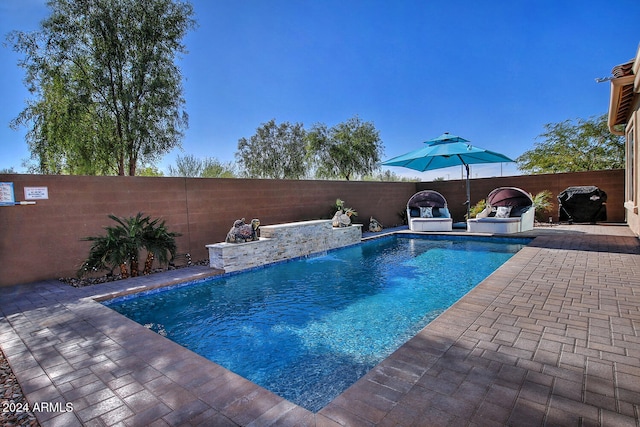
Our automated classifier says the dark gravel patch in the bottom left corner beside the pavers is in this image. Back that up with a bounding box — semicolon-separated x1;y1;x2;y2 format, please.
0;350;40;427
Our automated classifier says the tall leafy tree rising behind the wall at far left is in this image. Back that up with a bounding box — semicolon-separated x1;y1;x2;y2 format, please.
8;0;195;176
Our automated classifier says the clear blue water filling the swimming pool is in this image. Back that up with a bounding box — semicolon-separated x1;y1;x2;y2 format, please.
105;237;528;412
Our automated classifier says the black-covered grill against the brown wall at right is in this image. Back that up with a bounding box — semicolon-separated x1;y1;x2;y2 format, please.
558;185;607;223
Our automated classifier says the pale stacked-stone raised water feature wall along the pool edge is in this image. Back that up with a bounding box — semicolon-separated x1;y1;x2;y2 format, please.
206;219;362;273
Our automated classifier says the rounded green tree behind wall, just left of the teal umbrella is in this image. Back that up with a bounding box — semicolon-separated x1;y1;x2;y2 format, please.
308;116;383;180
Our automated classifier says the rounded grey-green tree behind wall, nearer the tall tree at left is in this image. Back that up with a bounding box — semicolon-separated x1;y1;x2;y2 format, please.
236;119;308;179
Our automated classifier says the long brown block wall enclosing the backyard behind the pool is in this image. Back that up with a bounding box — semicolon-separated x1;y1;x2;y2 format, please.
0;170;625;286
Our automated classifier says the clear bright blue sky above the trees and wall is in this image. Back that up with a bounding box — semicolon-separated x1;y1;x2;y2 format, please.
0;0;640;180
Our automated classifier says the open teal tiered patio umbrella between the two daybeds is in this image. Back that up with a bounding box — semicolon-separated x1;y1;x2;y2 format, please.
382;133;513;219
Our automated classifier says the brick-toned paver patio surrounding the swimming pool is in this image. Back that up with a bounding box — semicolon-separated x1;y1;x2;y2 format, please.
0;225;640;427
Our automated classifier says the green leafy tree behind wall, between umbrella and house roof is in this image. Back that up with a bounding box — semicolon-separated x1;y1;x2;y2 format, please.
516;114;624;173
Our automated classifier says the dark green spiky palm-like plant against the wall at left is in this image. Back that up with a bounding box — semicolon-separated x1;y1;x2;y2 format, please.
78;213;179;279
